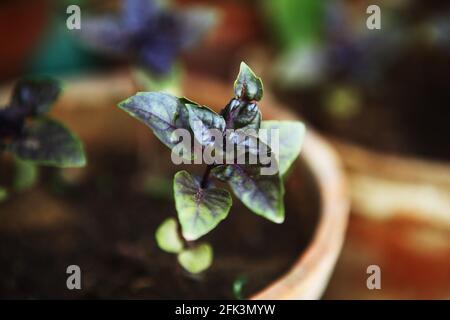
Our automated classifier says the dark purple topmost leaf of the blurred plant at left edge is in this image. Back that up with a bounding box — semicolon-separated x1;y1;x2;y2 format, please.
11;77;61;115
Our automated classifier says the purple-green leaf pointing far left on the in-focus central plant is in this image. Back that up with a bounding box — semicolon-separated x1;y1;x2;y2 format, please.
118;92;189;149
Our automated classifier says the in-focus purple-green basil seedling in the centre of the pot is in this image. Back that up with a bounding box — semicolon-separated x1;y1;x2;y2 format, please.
119;63;305;273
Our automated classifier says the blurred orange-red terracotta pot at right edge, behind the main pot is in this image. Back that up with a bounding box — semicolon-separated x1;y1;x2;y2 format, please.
327;140;450;299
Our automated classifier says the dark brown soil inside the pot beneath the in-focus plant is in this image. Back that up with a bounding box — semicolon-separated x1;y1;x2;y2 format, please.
0;146;320;299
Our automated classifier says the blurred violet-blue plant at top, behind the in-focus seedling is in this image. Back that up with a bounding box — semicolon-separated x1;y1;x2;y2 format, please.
79;0;214;80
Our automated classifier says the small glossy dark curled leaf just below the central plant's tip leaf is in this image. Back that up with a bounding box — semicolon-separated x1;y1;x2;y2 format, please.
222;98;262;130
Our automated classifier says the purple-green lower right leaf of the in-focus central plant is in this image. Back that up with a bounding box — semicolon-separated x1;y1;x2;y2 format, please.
211;164;284;223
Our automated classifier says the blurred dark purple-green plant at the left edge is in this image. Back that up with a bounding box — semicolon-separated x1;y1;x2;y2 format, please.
0;78;86;198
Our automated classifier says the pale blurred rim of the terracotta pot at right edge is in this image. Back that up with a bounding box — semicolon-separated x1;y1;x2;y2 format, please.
330;137;450;229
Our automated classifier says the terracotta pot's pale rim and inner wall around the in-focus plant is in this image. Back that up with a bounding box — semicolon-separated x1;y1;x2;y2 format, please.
0;71;349;299
